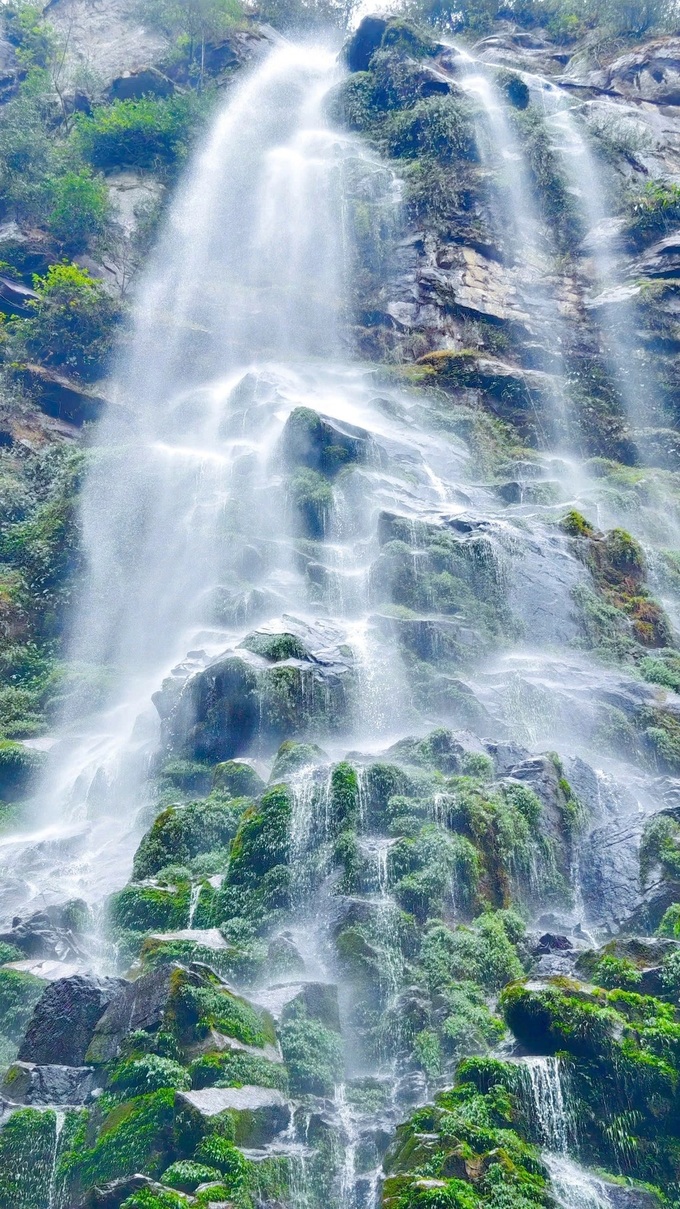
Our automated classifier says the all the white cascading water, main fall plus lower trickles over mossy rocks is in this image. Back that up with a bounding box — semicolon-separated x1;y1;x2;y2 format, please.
1;21;677;1209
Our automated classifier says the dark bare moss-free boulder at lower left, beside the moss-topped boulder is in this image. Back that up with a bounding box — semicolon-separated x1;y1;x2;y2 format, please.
18;974;124;1066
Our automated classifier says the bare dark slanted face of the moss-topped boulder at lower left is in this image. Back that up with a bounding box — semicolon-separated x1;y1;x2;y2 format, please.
87;962;181;1064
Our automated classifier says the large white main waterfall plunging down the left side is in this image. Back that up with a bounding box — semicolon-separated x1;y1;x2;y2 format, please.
1;45;399;906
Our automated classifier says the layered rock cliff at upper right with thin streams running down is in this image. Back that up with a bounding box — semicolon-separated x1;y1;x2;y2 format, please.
338;16;679;469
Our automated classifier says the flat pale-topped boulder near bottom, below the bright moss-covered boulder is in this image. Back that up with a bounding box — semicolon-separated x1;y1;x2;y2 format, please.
177;1086;290;1146
